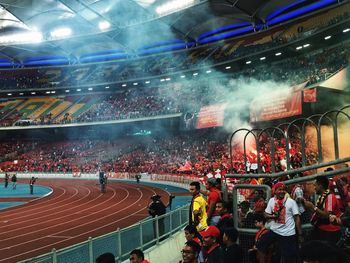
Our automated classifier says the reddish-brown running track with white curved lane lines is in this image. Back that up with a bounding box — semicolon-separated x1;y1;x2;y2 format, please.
0;179;174;263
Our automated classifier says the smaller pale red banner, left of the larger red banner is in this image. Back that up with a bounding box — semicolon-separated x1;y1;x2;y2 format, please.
196;103;226;129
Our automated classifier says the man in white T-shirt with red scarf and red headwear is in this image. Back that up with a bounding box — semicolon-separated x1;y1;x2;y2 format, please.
257;182;302;263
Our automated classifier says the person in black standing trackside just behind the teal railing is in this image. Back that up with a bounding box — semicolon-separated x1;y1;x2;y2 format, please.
148;194;166;238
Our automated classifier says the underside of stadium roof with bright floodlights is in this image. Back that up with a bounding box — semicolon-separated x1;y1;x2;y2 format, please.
0;0;344;63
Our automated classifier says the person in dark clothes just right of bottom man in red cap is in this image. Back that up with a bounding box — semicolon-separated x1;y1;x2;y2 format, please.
223;227;243;263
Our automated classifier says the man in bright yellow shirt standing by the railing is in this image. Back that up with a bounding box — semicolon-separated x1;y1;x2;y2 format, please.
189;182;208;232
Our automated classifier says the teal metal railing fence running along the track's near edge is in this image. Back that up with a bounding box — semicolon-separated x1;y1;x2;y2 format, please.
19;205;189;263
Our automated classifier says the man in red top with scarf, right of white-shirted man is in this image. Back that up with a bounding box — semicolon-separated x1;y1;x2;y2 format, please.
304;175;341;244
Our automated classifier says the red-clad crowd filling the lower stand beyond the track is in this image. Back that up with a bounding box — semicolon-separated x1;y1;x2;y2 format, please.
0;128;317;177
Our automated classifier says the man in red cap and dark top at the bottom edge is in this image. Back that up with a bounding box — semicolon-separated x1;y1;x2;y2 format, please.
200;226;224;263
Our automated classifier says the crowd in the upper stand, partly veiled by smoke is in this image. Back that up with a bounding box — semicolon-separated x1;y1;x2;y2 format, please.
0;39;350;126
